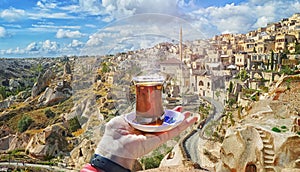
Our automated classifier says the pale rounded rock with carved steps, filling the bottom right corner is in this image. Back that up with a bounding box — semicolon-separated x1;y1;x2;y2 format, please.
216;126;300;172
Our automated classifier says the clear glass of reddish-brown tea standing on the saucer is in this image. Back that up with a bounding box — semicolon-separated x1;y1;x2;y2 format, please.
133;76;164;125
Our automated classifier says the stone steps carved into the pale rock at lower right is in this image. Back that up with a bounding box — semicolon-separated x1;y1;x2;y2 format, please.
256;128;276;172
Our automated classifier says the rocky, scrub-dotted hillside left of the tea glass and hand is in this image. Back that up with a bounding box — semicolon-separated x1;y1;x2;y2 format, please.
0;54;182;169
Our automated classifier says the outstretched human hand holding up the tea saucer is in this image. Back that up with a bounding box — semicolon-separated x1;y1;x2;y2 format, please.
95;106;197;169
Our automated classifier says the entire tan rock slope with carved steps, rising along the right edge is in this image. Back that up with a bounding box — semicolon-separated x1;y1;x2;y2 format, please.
216;76;300;171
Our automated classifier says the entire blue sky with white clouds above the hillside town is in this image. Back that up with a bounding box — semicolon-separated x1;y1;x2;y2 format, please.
0;0;300;57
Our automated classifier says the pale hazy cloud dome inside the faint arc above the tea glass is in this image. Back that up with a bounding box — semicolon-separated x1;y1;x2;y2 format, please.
82;14;204;55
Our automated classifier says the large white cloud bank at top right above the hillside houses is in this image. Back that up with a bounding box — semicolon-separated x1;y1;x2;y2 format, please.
187;0;300;36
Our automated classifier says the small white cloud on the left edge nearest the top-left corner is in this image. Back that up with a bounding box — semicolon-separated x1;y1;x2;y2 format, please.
0;7;26;22
